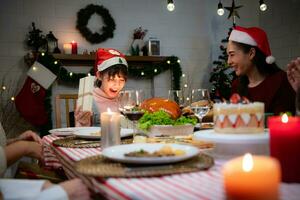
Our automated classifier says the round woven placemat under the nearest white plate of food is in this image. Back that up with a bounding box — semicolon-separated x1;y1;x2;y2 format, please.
75;154;214;178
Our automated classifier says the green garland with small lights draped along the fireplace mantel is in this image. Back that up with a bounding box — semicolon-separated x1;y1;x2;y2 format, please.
37;53;182;135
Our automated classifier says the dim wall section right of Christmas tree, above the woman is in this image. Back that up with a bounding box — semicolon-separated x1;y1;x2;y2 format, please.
259;0;300;69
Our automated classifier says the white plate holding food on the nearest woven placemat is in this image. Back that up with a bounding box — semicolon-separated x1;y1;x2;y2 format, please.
102;143;200;164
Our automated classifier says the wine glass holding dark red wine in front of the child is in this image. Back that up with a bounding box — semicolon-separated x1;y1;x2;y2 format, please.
119;90;144;141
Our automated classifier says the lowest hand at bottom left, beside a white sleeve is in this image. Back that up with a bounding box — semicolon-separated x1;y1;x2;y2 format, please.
59;178;90;200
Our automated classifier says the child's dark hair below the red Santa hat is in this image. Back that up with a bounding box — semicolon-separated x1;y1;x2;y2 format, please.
95;64;128;87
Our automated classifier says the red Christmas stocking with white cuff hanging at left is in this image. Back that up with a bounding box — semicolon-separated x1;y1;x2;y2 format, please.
15;61;56;126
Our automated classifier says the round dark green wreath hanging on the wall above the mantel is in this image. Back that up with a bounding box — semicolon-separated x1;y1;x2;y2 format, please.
76;4;116;44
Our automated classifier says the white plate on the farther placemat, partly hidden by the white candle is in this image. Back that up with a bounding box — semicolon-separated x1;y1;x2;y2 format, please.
73;127;133;139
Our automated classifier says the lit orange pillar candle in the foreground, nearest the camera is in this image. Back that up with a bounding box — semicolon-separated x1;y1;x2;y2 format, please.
223;154;280;200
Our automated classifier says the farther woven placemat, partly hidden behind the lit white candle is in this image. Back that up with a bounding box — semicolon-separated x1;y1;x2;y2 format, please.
53;136;133;148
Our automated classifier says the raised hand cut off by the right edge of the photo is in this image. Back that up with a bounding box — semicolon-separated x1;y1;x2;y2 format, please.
287;57;300;92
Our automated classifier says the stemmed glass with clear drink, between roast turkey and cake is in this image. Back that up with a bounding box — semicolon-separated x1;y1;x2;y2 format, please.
190;89;210;127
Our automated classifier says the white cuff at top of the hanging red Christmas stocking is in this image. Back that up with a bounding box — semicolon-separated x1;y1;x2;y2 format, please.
27;61;56;90
